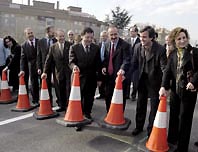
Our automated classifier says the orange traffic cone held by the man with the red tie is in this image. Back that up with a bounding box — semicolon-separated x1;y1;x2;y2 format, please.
101;74;131;130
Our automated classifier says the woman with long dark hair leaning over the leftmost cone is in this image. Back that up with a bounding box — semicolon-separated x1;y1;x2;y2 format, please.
3;36;21;91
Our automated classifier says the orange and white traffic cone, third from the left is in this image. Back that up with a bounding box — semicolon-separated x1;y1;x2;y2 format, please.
33;79;59;120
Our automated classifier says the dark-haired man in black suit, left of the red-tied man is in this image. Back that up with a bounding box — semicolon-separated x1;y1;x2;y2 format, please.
69;27;101;120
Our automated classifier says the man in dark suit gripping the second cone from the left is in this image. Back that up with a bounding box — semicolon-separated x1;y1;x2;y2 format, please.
19;27;39;104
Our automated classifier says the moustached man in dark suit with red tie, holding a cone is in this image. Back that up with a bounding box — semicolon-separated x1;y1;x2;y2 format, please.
102;26;130;112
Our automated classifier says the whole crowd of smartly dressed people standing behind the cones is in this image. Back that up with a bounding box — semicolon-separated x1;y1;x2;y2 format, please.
0;25;198;152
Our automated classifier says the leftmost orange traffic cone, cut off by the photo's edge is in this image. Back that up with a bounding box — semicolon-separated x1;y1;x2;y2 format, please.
0;71;17;104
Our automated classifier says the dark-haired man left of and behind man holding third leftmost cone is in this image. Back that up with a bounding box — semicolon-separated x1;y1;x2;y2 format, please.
37;26;57;105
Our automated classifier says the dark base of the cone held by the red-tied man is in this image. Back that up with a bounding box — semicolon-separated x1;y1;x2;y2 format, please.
99;118;131;130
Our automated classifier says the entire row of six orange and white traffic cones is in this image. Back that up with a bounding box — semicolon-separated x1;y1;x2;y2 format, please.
0;72;169;152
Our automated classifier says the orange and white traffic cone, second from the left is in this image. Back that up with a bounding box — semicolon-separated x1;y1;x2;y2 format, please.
11;76;37;112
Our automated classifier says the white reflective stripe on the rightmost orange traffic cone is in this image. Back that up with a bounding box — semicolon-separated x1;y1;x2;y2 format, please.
153;111;167;128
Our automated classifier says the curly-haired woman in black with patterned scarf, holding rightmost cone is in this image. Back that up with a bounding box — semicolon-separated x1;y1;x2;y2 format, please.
159;27;198;152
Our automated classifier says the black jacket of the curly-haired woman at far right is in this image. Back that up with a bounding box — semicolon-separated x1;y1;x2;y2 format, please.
162;45;198;91
